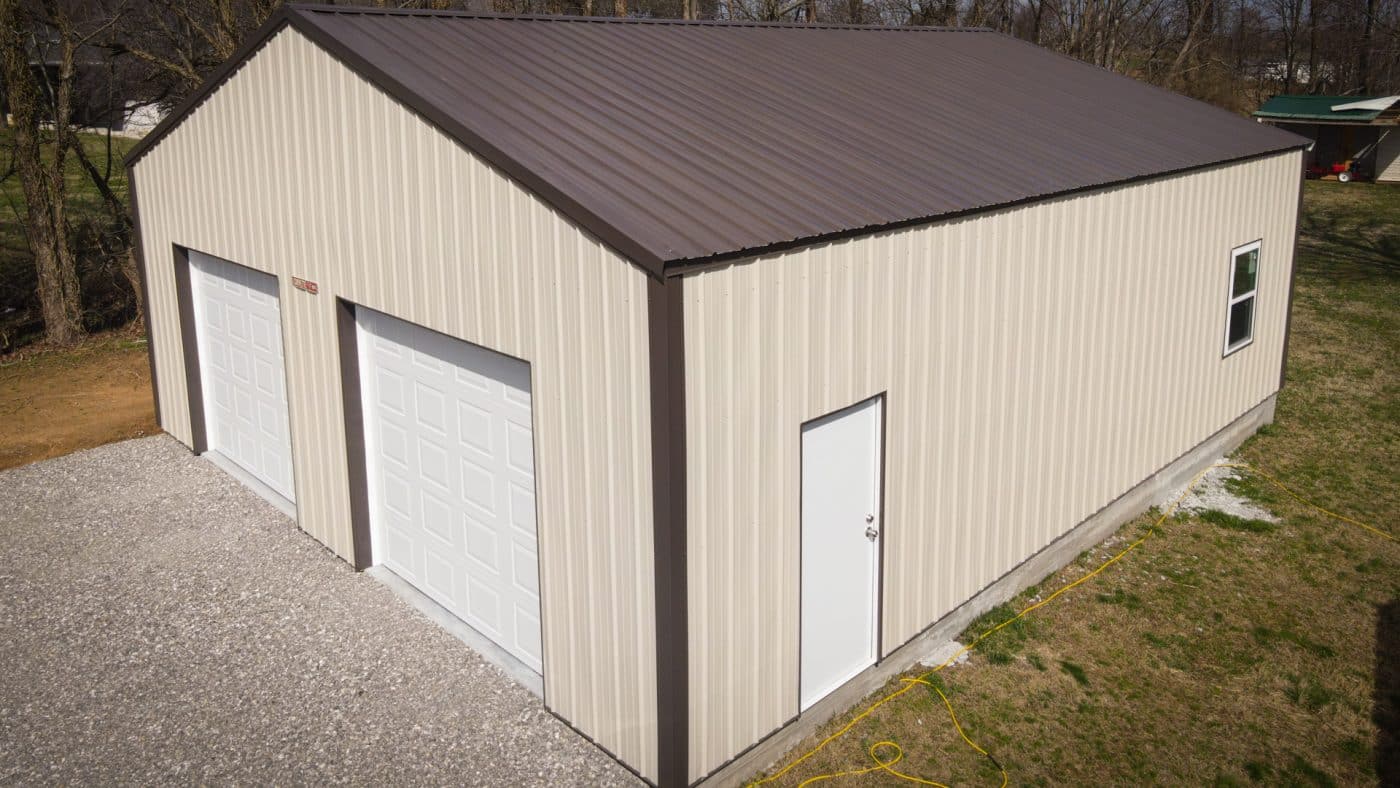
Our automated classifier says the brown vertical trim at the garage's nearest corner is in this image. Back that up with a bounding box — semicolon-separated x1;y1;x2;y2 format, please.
647;277;690;787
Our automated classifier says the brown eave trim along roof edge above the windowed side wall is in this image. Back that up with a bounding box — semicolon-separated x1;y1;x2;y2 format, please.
665;143;1313;277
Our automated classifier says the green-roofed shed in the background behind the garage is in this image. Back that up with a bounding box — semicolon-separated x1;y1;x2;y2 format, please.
1254;95;1400;182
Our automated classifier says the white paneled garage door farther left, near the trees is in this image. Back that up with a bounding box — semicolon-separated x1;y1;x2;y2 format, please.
189;251;295;502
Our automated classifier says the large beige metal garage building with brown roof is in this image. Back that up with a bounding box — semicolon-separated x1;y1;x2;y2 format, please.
130;7;1305;785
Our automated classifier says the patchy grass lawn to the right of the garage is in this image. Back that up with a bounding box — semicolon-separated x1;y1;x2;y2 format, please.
756;182;1400;785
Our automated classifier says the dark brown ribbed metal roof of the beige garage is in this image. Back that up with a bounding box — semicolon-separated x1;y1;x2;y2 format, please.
133;6;1306;272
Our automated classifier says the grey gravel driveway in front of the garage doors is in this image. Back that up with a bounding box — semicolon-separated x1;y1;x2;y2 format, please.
0;435;637;785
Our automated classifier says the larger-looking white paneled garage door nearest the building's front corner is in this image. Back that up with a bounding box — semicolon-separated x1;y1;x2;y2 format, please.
357;309;542;673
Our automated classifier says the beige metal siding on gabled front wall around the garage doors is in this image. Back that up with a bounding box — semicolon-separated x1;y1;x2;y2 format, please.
136;29;657;775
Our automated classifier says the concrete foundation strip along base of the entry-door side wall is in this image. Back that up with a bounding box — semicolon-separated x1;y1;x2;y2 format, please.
701;393;1278;787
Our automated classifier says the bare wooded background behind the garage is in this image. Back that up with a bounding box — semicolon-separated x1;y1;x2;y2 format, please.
0;0;1400;354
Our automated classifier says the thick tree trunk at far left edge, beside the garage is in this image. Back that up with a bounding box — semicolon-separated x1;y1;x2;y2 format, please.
0;0;83;346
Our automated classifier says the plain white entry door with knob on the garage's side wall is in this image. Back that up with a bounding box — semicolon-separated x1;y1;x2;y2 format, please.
799;399;882;711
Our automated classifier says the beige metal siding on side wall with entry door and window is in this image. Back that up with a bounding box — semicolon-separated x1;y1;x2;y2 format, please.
685;153;1301;777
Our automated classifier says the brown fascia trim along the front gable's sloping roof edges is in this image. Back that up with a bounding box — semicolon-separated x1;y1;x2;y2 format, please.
126;6;665;279
